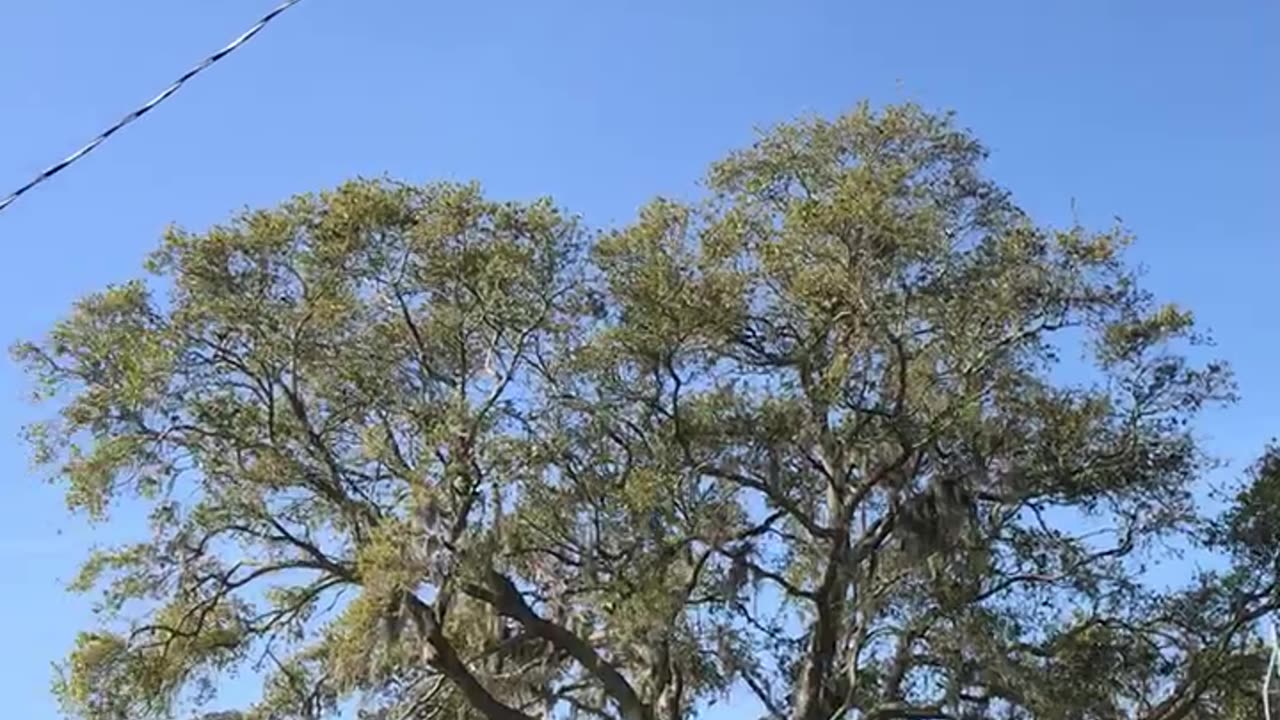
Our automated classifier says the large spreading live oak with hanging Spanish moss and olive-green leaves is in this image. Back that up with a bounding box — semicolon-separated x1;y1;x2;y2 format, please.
17;106;1280;720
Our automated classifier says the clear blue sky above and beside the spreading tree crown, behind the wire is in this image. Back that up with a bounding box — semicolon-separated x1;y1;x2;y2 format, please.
0;0;1280;720
